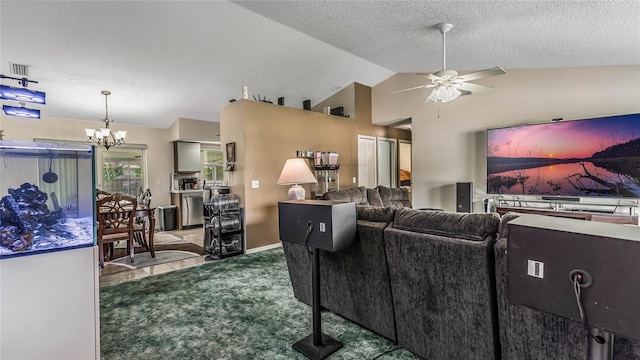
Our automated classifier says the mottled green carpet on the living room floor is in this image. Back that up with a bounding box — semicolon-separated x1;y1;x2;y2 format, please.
100;248;416;360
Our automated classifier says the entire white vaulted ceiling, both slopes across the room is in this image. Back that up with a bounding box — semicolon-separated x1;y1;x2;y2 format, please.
0;0;640;128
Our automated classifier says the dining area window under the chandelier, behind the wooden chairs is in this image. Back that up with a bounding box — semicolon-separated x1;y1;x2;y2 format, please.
97;146;146;196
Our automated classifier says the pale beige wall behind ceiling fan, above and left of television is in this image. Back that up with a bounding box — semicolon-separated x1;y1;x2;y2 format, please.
372;66;640;211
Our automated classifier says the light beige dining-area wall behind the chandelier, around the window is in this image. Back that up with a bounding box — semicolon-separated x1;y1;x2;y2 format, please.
0;111;218;212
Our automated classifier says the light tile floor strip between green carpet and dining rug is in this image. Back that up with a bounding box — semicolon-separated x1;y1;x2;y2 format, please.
100;227;205;287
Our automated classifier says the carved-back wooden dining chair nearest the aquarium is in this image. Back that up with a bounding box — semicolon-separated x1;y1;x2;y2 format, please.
96;193;144;268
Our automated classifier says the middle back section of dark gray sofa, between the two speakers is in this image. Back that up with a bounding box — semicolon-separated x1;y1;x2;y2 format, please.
383;208;500;360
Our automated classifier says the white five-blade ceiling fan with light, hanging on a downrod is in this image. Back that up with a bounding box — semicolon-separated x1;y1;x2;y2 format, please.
390;23;506;103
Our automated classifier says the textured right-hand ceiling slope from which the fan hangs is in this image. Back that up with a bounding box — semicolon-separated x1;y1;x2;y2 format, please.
236;1;640;72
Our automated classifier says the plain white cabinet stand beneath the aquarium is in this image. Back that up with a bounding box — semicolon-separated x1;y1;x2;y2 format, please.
0;246;100;360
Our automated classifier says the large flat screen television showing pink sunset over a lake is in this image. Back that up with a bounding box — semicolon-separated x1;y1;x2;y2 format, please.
487;114;640;198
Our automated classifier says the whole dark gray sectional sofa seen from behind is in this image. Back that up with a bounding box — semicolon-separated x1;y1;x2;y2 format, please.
283;187;640;360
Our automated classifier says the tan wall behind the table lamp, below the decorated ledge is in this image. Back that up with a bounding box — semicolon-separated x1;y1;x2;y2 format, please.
220;84;411;249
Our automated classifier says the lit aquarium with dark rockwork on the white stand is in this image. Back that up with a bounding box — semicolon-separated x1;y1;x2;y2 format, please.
0;141;95;259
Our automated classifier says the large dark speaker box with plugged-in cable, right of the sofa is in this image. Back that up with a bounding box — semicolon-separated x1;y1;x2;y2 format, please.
507;215;640;360
